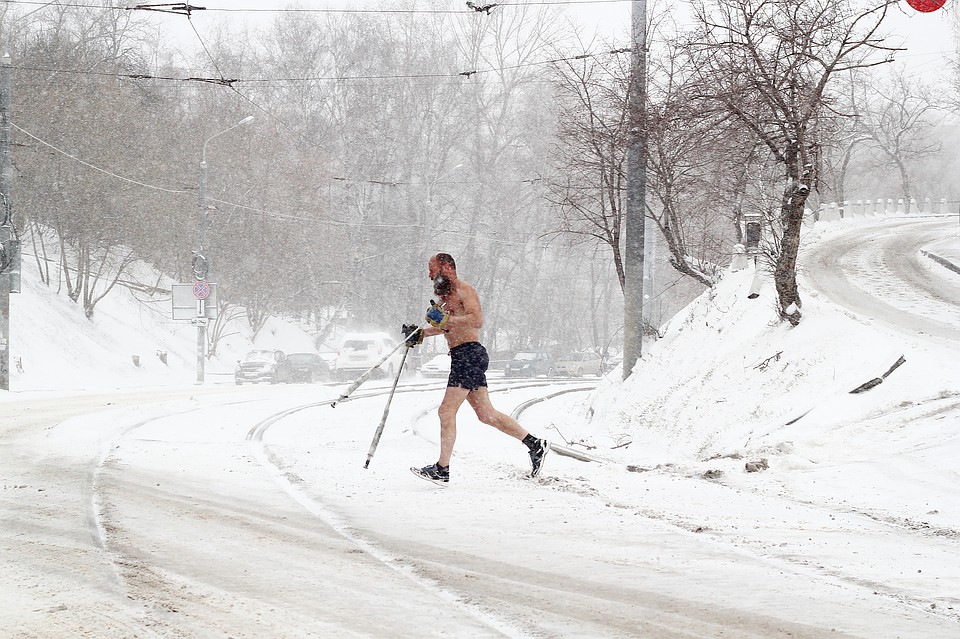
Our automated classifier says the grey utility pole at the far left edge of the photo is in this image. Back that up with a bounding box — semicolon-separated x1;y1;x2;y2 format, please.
0;54;14;390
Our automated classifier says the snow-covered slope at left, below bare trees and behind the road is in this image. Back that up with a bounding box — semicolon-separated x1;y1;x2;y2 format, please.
10;261;315;392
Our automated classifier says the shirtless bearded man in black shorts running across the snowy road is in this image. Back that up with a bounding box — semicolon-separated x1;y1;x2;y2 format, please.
410;253;550;484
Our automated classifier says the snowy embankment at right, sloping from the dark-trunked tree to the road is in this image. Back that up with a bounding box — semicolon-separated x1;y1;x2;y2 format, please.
539;212;960;568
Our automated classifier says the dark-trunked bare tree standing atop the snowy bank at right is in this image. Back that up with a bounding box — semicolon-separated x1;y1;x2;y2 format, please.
691;0;894;325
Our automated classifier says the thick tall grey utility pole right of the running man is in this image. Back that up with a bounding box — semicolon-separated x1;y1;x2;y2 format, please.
623;0;647;379
